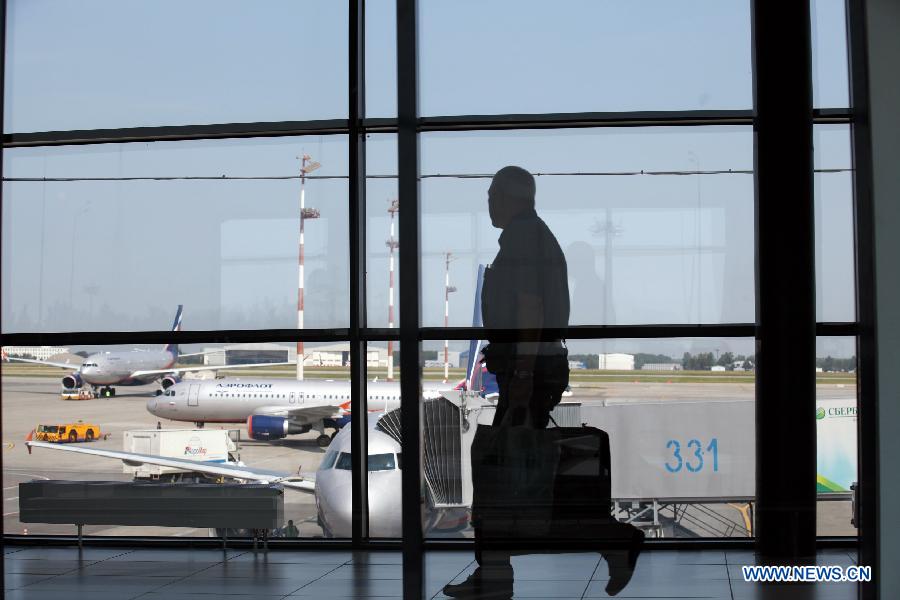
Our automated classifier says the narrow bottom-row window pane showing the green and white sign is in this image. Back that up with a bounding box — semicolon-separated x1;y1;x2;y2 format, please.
816;337;858;536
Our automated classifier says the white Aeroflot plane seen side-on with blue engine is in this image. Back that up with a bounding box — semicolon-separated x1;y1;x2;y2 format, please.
147;377;450;448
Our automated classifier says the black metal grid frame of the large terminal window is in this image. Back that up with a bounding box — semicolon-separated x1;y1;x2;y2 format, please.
0;0;875;574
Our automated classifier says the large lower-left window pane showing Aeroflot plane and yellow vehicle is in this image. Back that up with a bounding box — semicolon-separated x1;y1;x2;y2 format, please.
0;342;356;537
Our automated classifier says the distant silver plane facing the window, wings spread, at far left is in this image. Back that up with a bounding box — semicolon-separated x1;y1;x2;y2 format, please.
4;304;293;397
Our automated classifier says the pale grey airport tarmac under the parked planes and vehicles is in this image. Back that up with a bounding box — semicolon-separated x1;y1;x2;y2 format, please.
2;376;856;537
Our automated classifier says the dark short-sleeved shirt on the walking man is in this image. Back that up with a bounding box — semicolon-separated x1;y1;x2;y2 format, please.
481;210;569;354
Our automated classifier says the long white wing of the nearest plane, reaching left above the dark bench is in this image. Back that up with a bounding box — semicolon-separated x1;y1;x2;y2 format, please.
25;442;316;492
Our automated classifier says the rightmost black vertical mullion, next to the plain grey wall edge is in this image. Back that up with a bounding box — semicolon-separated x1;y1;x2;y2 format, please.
846;0;881;600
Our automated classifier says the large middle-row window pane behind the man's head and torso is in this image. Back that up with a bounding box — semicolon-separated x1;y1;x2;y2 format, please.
421;127;755;326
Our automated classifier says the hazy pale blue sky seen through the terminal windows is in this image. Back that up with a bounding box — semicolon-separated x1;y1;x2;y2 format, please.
2;0;854;356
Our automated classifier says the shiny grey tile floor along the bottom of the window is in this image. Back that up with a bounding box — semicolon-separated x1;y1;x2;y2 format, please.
3;546;857;600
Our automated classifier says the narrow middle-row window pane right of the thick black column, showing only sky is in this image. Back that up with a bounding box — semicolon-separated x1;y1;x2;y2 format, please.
814;125;856;321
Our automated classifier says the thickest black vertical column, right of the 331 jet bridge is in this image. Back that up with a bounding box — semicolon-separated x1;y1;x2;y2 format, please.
752;0;816;559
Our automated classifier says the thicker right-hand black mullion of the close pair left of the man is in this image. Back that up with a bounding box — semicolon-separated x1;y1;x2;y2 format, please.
397;0;425;600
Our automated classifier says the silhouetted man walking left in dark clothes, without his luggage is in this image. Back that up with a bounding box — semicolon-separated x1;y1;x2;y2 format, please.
444;166;643;599
